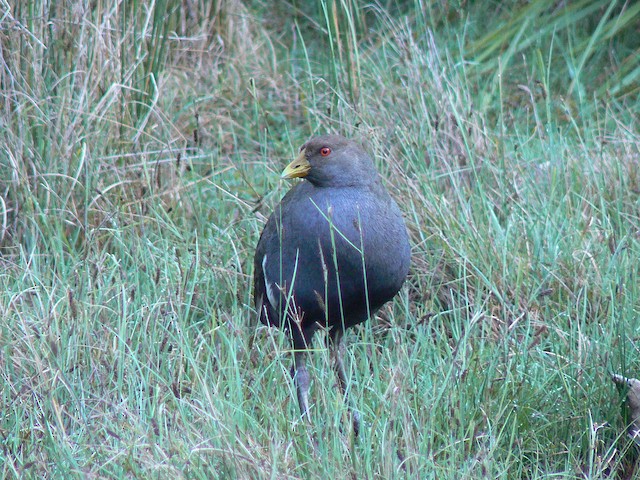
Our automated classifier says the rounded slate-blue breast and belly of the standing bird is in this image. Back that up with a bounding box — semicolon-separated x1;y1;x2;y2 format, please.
262;188;408;323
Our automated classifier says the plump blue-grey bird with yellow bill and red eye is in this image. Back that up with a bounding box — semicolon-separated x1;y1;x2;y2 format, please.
254;135;411;436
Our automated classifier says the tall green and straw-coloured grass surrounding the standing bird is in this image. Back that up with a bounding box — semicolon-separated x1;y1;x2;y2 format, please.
0;0;640;479
